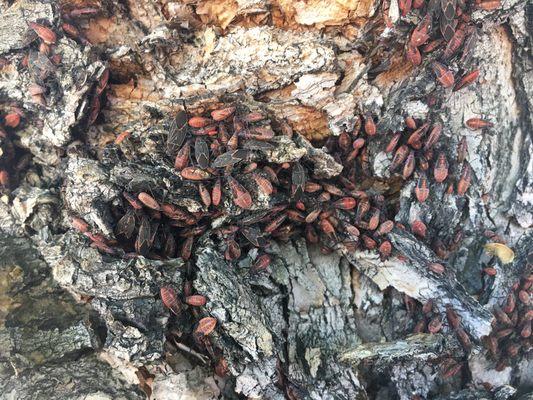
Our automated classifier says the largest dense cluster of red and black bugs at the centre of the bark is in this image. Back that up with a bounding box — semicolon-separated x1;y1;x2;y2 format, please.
72;105;408;262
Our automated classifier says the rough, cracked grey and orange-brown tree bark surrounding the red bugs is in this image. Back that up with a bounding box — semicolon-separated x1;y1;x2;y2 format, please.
0;0;533;400
